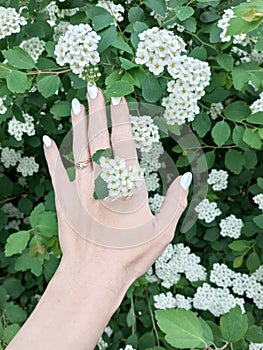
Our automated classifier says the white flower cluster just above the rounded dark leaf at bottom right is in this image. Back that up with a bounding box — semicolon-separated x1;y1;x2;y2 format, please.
193;283;245;317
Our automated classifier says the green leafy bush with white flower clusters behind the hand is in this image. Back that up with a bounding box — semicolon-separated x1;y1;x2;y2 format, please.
0;0;263;350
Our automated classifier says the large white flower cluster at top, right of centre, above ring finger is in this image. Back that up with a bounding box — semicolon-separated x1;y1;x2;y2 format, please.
135;27;186;75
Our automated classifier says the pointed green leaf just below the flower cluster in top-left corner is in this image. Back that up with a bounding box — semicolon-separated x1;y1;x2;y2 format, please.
2;47;35;69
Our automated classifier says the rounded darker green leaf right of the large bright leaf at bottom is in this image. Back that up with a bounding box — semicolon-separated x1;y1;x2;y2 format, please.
220;306;248;343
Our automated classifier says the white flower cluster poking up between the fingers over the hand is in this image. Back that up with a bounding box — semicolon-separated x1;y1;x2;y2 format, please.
100;157;143;198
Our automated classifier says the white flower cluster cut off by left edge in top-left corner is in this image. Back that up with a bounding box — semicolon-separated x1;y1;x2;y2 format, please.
0;6;27;39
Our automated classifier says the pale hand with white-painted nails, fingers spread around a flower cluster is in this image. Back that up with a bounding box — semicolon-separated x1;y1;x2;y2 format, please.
44;86;192;285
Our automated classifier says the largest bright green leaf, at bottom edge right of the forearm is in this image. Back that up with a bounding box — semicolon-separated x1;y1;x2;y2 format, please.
155;309;206;349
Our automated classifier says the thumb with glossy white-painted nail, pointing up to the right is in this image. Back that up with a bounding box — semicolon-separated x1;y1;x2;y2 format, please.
155;172;192;235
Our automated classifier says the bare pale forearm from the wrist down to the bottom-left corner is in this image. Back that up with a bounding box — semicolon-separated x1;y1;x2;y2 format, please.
7;258;128;350
